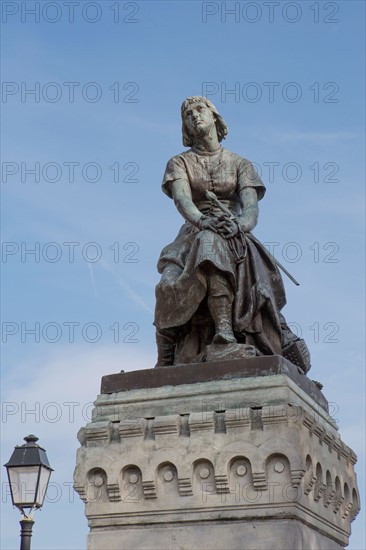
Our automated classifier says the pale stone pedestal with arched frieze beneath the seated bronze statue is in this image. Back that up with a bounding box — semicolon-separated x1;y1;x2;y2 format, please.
74;357;359;550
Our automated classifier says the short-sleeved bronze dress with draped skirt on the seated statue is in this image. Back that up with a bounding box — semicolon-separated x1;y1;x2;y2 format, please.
155;148;286;355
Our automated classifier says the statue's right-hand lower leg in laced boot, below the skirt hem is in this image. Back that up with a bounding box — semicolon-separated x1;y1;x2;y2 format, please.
207;266;236;344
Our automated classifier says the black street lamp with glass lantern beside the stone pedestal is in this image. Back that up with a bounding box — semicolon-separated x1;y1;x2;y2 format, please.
4;435;53;550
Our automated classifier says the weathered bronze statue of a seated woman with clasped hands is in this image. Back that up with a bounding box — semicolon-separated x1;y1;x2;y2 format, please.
154;96;310;373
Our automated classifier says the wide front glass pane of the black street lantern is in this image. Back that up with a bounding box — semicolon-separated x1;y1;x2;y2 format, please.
8;466;39;508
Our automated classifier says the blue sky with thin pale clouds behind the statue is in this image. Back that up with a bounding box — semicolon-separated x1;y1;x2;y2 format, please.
1;0;365;550
